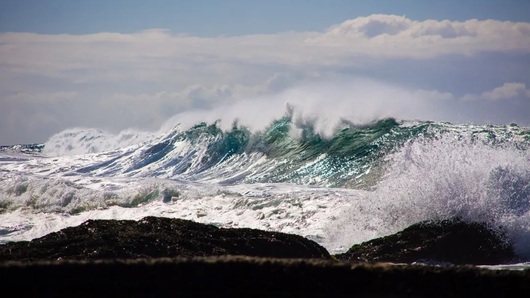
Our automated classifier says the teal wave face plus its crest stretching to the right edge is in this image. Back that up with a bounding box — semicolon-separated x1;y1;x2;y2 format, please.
175;117;530;188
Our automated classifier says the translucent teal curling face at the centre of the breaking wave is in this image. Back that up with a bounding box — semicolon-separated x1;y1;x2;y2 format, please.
159;117;398;187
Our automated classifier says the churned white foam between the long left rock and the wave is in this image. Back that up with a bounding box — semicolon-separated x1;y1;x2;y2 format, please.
0;179;355;250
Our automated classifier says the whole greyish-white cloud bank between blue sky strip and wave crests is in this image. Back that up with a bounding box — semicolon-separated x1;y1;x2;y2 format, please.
0;15;530;145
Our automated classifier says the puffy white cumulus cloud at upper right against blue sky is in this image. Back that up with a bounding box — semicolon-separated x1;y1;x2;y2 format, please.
313;15;530;59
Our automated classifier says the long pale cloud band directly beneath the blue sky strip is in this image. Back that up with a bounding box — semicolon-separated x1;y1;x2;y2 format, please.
0;15;530;82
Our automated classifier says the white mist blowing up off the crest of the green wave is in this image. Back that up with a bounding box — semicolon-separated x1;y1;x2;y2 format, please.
161;77;455;138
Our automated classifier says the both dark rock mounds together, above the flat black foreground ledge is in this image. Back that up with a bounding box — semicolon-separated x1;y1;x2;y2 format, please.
0;217;516;265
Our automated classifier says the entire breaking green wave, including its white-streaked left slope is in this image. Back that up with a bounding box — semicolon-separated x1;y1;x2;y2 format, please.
52;116;530;189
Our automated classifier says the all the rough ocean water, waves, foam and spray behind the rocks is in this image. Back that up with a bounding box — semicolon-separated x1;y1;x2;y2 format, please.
0;114;530;268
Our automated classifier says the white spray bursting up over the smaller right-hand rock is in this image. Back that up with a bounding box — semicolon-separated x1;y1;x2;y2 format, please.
331;130;530;259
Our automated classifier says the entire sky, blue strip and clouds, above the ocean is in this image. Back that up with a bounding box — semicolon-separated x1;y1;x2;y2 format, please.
0;0;530;145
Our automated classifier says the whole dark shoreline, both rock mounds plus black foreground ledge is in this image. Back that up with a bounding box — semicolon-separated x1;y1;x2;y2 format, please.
0;217;530;297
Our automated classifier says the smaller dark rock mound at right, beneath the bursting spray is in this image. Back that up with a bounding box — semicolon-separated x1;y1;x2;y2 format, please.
335;218;516;265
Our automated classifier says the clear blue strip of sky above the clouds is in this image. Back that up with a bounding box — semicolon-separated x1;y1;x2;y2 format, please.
0;0;530;36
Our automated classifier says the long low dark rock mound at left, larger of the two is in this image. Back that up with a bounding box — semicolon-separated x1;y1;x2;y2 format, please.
0;217;330;262
